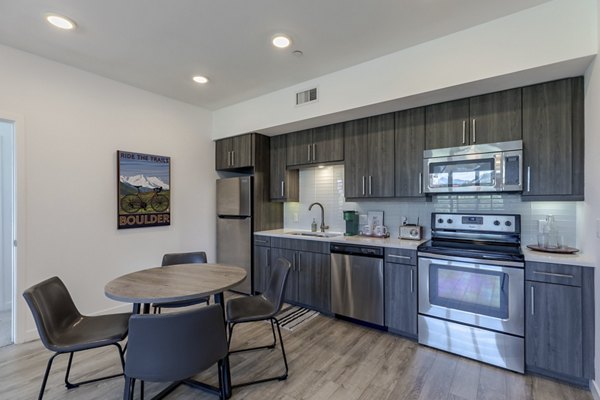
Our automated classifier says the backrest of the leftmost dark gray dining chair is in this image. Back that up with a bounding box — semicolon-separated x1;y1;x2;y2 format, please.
23;276;82;351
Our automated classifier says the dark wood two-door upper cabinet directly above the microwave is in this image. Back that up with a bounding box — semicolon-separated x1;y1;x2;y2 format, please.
425;88;522;149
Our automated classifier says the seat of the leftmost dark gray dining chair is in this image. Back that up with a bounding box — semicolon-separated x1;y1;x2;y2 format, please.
49;313;131;353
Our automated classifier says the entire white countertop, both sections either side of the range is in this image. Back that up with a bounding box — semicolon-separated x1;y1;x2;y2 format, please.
255;229;600;268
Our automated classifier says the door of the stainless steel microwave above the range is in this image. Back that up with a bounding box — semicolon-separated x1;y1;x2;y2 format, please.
423;153;504;193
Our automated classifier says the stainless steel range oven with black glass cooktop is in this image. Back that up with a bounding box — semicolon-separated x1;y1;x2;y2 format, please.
418;213;525;373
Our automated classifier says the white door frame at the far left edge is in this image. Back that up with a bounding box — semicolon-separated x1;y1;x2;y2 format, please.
0;109;28;343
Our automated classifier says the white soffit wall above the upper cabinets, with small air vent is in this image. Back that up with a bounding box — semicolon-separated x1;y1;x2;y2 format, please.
213;0;596;138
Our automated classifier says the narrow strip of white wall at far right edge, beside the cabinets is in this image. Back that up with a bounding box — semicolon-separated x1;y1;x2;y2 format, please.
582;2;600;400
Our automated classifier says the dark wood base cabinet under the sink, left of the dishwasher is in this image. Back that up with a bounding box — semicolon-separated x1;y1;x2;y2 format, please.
271;238;331;313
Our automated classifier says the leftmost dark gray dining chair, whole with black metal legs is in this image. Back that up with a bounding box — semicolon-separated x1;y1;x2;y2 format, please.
23;276;131;399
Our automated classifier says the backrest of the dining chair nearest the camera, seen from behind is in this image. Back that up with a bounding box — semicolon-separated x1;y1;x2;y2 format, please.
125;304;227;382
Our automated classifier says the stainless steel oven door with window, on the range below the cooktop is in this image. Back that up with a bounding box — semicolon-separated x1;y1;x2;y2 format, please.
419;256;525;336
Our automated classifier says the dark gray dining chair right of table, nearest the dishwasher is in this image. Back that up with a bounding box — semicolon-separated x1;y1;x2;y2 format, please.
226;258;291;387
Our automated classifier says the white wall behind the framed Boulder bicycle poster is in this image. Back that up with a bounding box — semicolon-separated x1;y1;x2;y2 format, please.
0;46;216;339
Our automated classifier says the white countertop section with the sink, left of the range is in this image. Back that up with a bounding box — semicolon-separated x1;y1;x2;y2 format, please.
254;229;425;250
